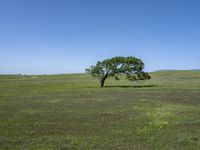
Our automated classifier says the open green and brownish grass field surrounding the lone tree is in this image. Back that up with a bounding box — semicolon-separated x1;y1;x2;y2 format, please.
0;71;200;150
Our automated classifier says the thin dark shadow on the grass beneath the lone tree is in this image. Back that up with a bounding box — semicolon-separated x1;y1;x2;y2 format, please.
104;84;158;88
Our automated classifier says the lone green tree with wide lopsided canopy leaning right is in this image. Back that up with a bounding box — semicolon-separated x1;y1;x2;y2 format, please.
86;56;151;87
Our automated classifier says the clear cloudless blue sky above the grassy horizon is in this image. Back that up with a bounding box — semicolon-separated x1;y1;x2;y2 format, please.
0;0;200;74
